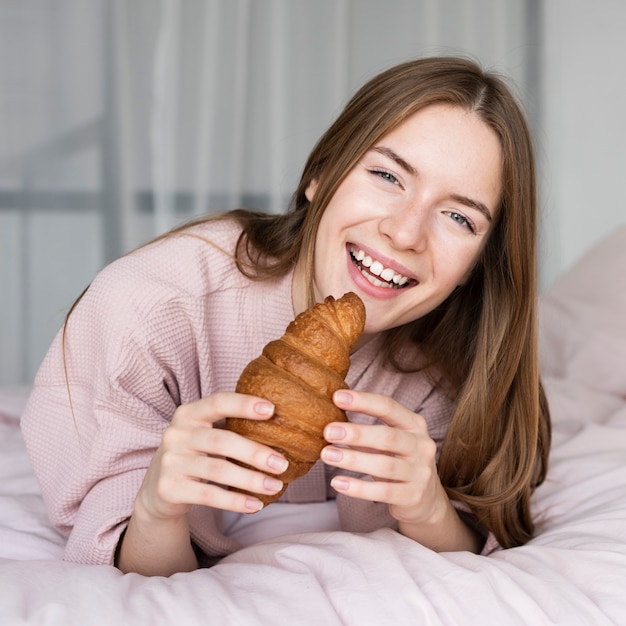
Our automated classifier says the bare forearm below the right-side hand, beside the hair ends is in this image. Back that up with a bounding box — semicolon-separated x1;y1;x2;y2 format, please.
398;497;484;554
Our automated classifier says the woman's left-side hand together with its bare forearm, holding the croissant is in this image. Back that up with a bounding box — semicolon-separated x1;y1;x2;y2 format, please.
115;392;287;576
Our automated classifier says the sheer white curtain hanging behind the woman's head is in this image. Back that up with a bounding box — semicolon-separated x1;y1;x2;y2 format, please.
105;0;530;255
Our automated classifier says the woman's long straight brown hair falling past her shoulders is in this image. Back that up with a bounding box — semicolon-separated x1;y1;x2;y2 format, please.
69;57;550;547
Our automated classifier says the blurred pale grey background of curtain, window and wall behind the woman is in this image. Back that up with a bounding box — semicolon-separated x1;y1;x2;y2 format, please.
0;0;626;386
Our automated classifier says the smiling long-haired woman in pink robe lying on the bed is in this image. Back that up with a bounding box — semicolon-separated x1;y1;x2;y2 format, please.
23;58;550;575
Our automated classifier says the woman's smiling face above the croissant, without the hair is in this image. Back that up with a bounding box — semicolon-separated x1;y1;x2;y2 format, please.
304;104;502;334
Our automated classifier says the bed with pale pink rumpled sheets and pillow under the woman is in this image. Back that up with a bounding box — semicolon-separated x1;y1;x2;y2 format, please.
0;227;626;626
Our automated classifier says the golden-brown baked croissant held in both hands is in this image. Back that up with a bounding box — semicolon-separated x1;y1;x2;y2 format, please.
226;292;365;504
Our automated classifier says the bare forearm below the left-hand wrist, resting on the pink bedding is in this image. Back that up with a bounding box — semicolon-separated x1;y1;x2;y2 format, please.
116;504;198;576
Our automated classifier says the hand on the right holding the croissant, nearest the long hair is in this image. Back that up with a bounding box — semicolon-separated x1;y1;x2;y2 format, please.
322;390;450;525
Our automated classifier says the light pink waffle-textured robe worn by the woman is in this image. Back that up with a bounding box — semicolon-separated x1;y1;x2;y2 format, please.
22;221;493;564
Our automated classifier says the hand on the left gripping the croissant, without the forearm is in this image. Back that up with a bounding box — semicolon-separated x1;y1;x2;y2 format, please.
135;392;287;520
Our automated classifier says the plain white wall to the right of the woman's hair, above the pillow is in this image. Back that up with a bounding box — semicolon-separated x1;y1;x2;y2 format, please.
537;0;626;286
